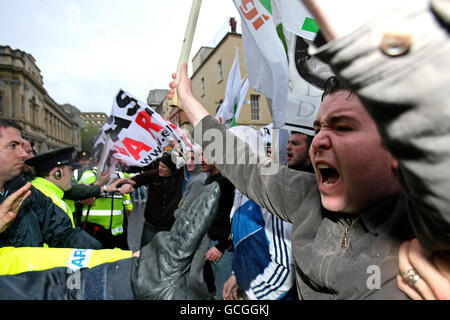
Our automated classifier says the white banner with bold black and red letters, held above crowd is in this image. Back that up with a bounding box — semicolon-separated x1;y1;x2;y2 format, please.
94;89;192;167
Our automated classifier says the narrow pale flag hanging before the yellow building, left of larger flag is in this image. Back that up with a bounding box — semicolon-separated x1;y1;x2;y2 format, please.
216;47;242;127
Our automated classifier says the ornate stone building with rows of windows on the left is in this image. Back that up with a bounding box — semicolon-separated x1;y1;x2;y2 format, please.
0;46;81;153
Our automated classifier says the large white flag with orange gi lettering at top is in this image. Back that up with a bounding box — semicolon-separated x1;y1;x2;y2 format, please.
233;0;288;128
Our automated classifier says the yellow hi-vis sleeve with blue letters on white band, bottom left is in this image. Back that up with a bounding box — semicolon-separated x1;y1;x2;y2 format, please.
0;247;133;275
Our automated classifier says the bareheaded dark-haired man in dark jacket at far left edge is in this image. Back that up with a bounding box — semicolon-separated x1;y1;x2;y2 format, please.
0;118;101;249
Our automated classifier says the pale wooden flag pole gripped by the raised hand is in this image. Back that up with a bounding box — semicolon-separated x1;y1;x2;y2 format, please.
169;0;202;110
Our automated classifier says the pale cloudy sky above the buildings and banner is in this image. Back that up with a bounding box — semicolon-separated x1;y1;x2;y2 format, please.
0;0;240;114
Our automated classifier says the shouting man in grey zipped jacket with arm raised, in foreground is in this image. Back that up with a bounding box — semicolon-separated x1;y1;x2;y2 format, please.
168;1;450;299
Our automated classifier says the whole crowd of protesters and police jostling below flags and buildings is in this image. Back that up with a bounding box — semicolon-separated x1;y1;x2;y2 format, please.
0;0;450;300
